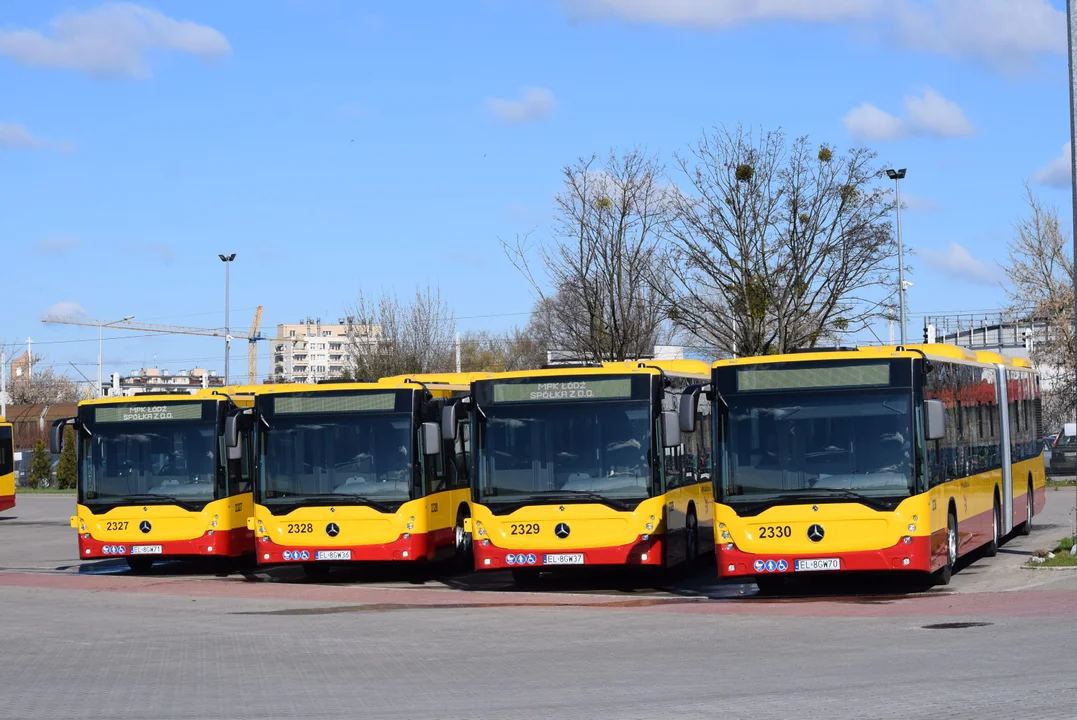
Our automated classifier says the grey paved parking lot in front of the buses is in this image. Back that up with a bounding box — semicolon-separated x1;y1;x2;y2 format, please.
0;489;1077;720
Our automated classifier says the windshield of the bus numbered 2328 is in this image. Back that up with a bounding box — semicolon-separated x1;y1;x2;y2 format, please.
255;413;411;506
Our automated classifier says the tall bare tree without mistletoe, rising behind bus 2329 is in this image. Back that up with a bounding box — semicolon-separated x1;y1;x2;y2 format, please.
502;150;669;361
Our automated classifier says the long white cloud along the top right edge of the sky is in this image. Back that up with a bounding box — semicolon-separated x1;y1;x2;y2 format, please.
561;0;1066;69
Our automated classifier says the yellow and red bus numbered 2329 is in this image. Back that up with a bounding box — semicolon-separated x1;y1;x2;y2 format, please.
468;361;713;583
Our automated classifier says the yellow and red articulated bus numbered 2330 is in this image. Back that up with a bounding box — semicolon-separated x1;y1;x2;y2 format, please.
683;344;1046;592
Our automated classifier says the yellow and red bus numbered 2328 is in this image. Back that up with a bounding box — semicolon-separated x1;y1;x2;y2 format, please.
249;373;488;577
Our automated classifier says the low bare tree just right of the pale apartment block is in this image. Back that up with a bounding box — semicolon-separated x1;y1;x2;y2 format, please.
347;285;456;378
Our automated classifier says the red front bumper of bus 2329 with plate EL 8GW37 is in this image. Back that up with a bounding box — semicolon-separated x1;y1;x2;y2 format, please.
474;535;663;570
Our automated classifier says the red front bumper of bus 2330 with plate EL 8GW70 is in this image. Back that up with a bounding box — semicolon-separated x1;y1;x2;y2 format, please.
717;535;934;578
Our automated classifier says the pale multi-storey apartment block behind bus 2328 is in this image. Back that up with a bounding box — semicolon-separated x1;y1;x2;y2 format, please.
272;317;378;382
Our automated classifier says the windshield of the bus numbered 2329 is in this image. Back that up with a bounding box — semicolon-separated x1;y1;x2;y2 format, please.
476;400;652;505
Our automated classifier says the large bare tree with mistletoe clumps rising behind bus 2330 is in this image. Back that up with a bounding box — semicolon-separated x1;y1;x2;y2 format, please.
656;126;897;355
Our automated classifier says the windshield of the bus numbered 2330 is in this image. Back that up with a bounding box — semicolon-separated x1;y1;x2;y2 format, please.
722;391;914;506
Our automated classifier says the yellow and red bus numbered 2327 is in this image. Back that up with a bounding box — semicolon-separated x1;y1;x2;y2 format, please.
51;387;254;573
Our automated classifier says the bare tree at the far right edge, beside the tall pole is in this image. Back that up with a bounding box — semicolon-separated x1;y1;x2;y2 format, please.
1004;185;1077;428
